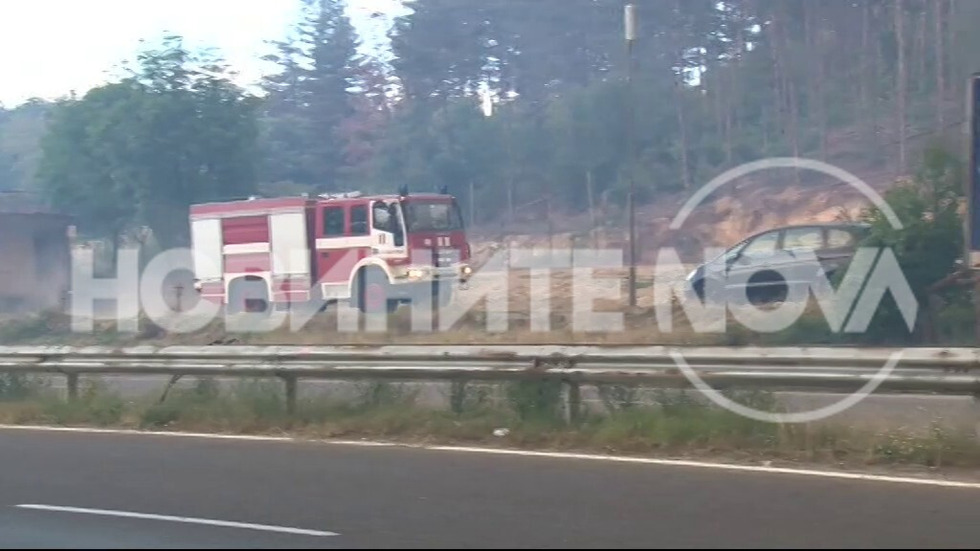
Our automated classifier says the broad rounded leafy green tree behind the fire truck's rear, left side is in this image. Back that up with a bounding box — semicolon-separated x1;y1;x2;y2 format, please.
38;37;257;246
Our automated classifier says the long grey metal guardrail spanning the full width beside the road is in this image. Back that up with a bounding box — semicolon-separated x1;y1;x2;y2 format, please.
0;346;980;411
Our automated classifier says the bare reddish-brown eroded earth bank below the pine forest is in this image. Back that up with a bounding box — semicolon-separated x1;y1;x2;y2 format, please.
471;158;895;265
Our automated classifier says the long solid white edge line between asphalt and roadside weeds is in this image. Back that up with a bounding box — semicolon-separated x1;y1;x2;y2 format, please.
0;425;980;490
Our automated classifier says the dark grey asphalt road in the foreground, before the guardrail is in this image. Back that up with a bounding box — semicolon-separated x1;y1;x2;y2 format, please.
0;429;980;548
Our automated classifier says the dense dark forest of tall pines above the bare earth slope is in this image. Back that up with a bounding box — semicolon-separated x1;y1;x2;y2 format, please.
253;0;980;230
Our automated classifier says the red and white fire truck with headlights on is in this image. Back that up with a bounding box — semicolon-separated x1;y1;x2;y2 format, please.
190;188;472;313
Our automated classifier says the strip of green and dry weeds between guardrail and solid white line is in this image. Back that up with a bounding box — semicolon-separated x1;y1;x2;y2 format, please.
0;375;980;478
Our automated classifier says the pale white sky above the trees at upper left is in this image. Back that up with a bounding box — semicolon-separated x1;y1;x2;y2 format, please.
0;0;402;108
